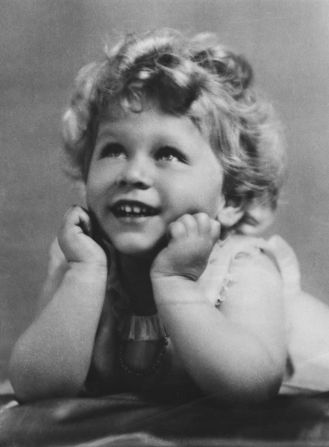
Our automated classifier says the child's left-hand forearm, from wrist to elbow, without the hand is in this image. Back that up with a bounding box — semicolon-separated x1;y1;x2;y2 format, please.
10;263;107;401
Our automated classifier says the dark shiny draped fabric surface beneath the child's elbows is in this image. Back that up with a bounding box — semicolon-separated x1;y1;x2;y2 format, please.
0;393;329;447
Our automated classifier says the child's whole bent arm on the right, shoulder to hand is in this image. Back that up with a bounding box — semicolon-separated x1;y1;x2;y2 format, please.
152;215;286;402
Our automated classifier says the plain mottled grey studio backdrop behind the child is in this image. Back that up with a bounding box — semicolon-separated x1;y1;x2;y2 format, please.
0;0;329;378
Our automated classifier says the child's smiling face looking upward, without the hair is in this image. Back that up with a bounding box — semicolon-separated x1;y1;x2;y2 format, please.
86;107;224;256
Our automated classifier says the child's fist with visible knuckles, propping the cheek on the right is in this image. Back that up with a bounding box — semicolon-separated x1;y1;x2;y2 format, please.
151;213;220;281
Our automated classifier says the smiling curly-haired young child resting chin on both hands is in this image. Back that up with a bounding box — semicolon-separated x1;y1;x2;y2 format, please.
10;30;329;403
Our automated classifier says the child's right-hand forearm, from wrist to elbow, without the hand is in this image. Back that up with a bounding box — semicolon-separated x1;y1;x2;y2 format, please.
153;277;285;402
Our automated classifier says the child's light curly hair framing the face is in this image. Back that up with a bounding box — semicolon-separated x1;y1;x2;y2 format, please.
63;29;285;233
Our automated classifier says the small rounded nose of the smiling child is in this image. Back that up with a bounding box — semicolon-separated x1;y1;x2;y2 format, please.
118;158;153;189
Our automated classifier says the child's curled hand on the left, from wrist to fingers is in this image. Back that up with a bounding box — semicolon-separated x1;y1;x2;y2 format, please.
58;206;107;267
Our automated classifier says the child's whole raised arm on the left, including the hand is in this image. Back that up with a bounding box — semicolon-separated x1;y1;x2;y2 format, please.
10;207;107;401
